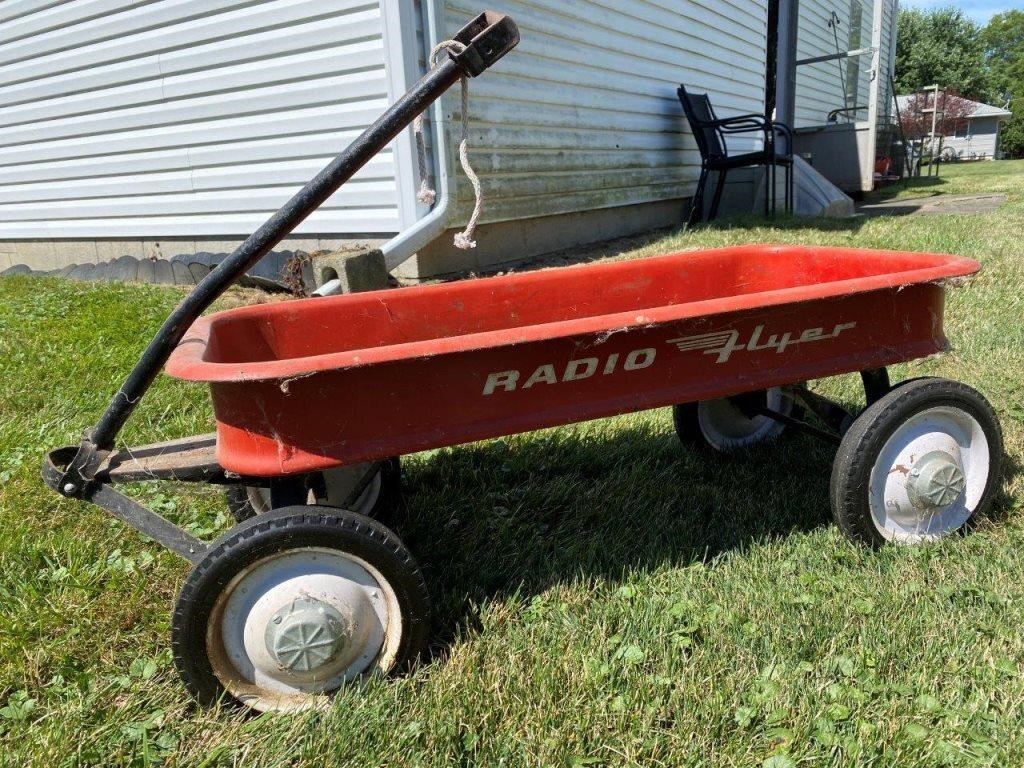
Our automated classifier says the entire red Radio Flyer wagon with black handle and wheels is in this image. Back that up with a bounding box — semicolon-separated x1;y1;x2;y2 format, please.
43;12;1002;710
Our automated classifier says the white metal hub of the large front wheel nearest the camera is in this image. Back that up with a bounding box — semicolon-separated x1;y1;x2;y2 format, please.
207;548;401;710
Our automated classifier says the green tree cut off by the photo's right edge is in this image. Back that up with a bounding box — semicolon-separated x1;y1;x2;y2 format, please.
981;10;1024;158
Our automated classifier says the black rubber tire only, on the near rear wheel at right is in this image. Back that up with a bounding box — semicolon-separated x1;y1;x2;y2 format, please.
828;377;1004;549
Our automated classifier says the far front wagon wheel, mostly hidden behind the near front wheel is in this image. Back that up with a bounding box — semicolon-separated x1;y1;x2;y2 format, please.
224;457;401;522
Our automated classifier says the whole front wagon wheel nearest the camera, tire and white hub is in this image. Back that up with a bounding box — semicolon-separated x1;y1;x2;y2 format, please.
172;507;430;712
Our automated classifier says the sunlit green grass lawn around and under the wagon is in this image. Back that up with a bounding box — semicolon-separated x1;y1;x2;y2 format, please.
0;162;1024;768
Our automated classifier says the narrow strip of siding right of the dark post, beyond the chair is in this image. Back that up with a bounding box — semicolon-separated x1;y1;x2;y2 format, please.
794;0;887;128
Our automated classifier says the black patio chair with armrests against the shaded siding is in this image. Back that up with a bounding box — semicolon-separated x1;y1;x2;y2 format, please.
679;85;793;224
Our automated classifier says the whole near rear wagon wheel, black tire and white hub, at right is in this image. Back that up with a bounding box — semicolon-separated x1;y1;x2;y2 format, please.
829;379;1002;547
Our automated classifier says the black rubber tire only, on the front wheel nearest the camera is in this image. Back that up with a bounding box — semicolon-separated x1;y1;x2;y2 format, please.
171;506;431;707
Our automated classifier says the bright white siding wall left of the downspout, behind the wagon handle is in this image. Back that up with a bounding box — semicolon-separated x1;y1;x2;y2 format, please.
0;0;399;239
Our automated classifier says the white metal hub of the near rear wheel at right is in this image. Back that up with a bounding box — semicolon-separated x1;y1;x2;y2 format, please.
868;407;989;544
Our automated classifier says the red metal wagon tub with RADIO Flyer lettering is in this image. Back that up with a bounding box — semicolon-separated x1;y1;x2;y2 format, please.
167;246;978;476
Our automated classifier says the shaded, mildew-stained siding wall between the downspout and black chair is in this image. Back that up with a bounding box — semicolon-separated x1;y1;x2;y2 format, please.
445;0;767;227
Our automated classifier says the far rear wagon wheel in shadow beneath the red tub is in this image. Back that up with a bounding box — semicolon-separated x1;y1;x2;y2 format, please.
672;387;798;454
